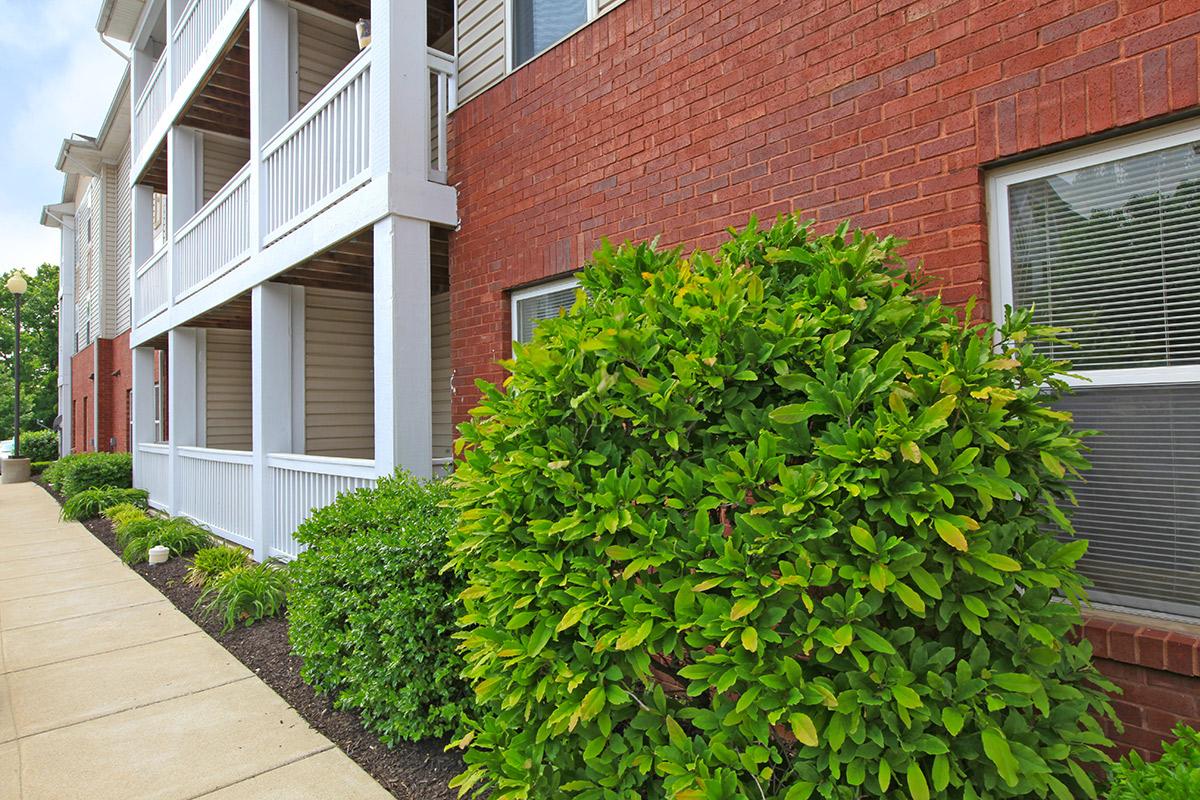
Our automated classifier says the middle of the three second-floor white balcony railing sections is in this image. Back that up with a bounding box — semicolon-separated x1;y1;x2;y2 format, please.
172;163;252;301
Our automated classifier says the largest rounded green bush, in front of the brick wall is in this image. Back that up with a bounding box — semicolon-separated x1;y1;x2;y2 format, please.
451;218;1111;800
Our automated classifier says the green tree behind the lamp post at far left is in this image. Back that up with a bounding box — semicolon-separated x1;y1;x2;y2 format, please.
0;264;59;439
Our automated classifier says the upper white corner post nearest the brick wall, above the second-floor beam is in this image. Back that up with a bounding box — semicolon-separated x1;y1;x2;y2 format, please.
371;0;430;183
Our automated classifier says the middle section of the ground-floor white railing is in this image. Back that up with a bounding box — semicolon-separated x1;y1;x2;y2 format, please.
175;447;254;547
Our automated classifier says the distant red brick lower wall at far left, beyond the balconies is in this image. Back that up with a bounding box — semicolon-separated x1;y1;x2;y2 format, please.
71;332;133;452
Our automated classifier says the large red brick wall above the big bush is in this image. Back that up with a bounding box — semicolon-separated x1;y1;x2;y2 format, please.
450;0;1200;420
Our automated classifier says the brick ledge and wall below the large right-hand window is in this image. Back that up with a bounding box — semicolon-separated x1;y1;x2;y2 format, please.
1081;609;1200;758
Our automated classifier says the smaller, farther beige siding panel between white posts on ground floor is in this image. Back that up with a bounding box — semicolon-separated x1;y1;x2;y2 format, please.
204;329;253;450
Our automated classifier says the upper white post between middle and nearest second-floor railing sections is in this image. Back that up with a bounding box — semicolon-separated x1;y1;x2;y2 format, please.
250;0;292;252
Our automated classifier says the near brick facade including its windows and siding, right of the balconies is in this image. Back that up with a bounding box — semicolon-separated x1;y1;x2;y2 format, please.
450;0;1200;751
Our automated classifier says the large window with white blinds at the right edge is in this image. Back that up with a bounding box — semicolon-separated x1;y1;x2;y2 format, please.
989;124;1200;618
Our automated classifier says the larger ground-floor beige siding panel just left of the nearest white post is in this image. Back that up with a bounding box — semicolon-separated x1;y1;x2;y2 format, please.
304;288;374;458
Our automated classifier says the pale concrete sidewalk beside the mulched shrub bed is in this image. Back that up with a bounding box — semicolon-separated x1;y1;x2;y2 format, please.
0;483;391;800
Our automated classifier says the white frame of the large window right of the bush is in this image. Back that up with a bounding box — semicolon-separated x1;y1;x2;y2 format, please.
986;120;1200;386
